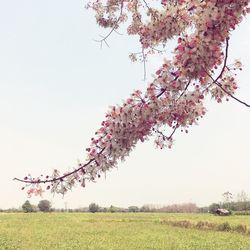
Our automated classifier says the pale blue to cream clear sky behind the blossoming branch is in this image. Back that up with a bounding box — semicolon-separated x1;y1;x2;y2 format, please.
0;0;250;208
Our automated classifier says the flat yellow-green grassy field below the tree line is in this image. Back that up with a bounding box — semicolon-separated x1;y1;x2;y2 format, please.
0;213;250;250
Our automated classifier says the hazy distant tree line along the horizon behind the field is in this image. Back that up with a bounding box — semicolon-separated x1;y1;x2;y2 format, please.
0;191;250;215
